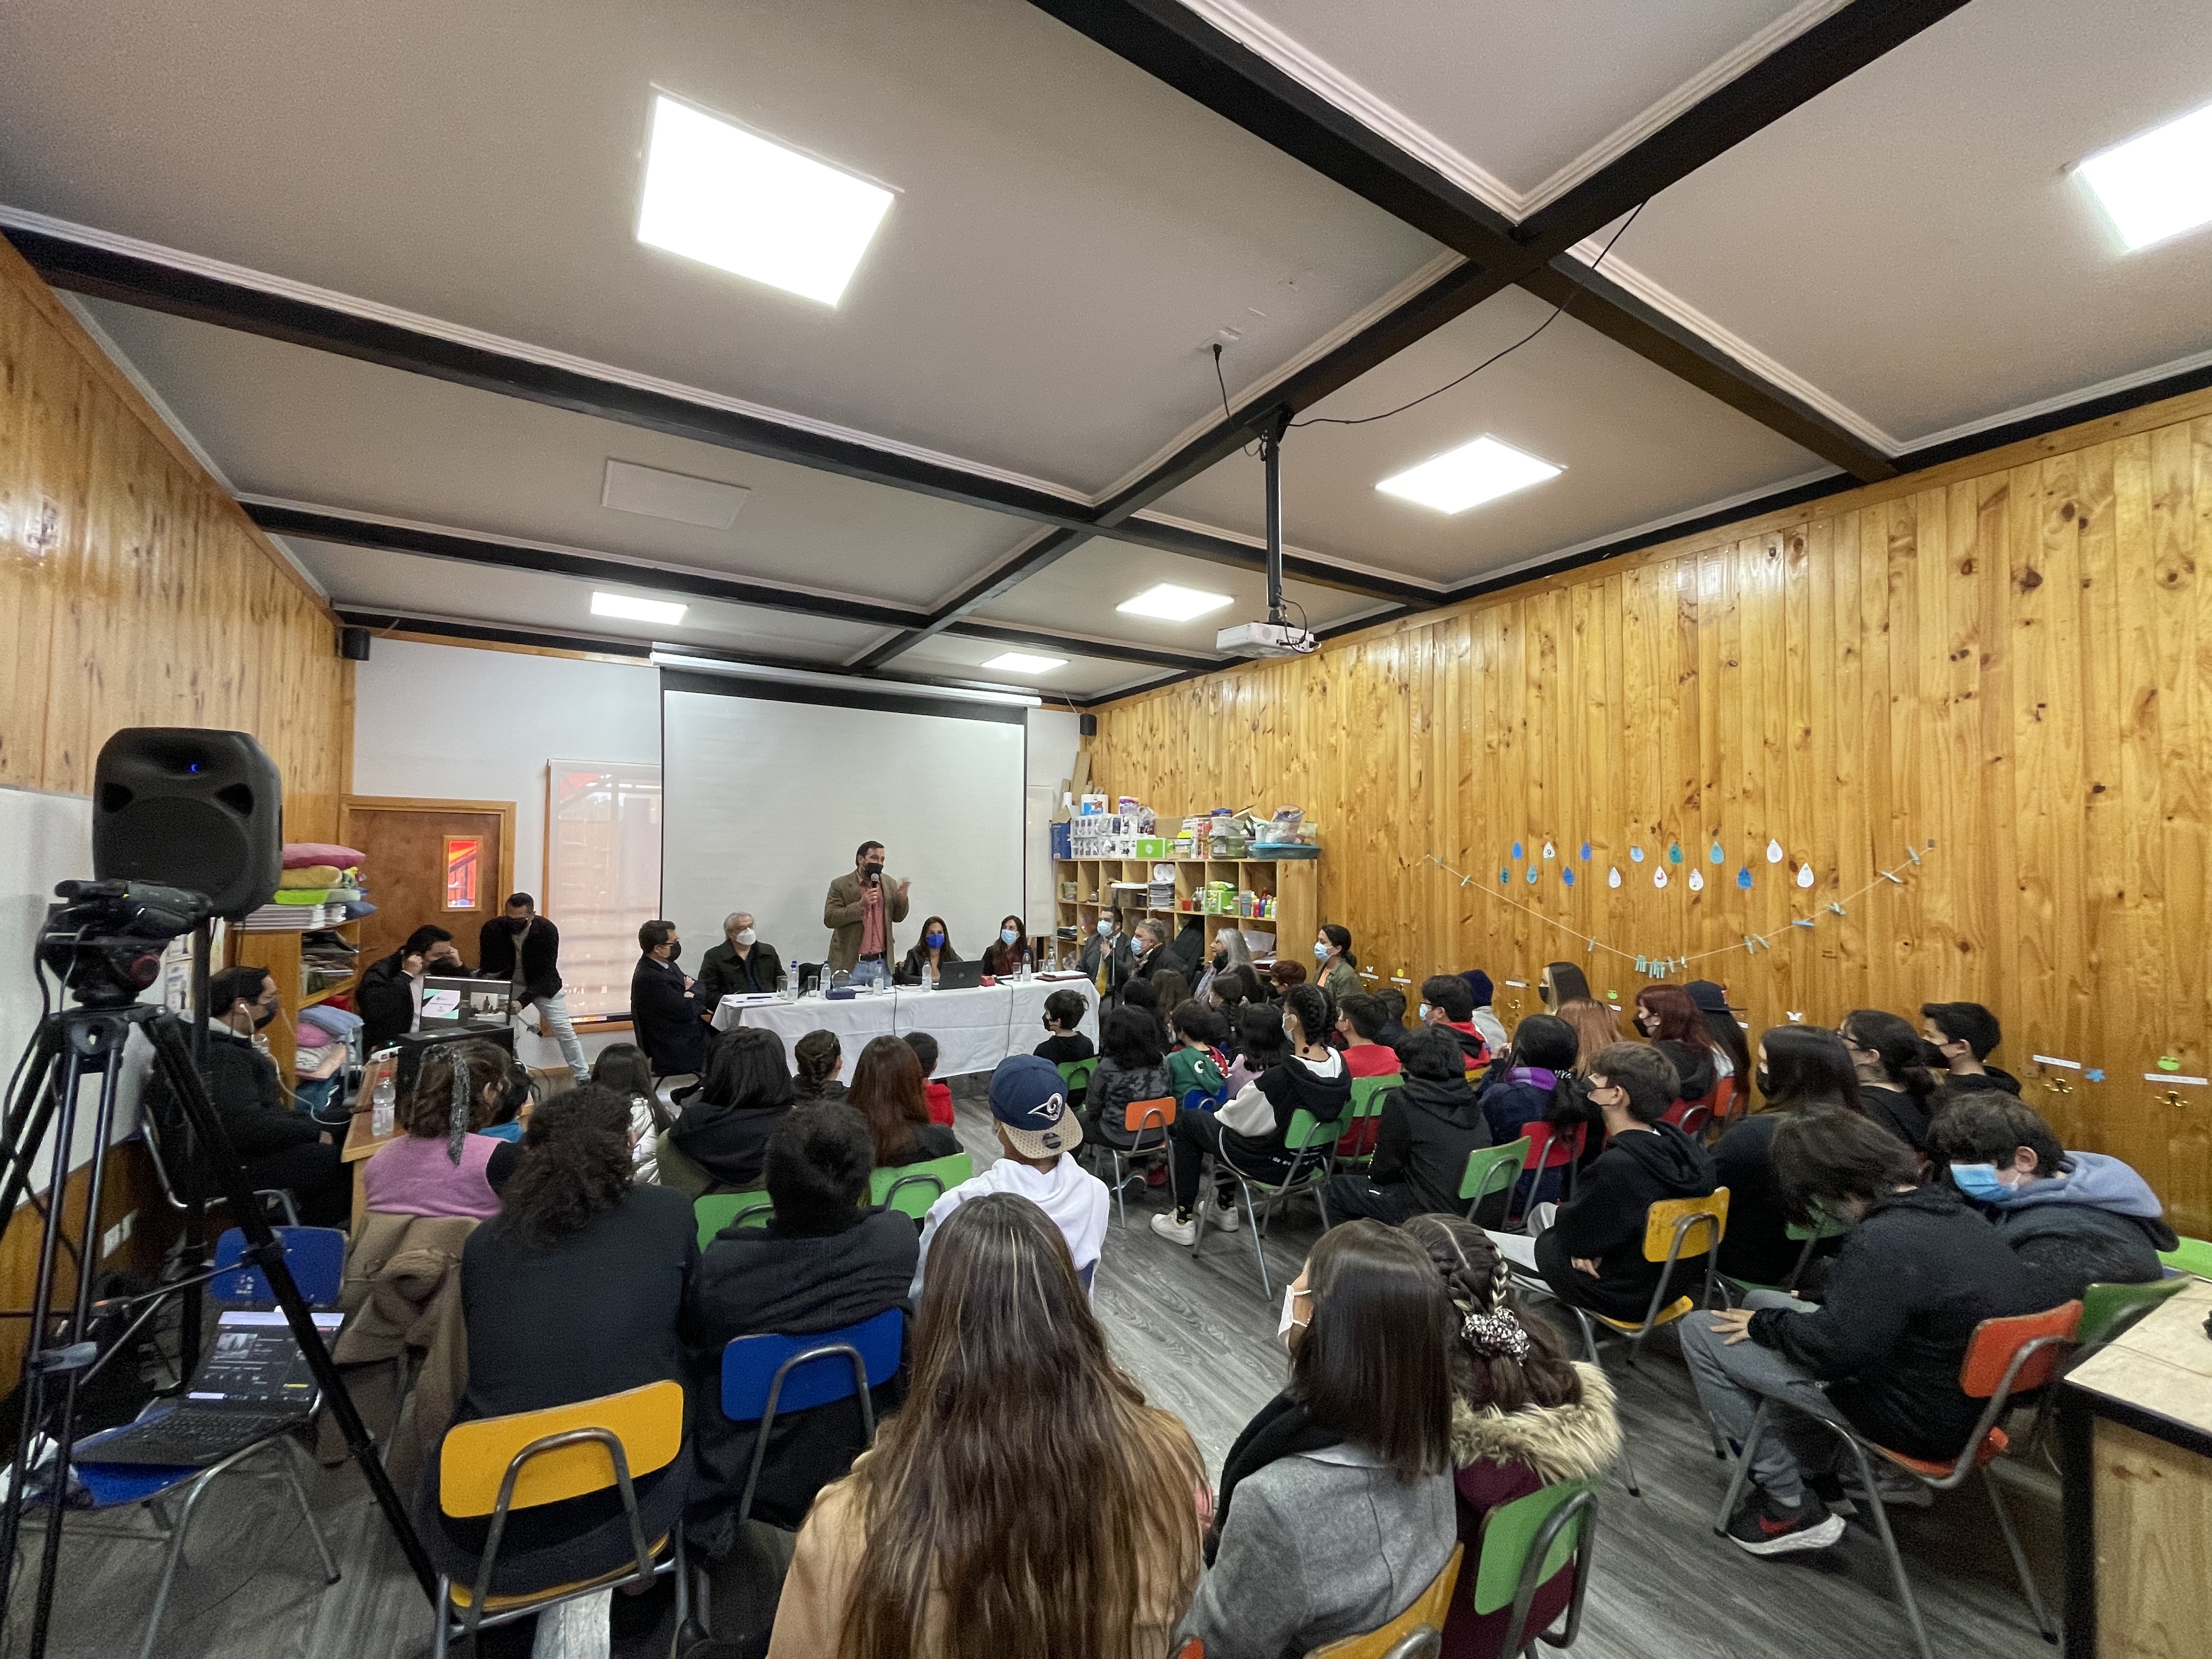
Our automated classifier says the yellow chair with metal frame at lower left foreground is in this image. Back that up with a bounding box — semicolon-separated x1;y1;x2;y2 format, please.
431;1383;692;1659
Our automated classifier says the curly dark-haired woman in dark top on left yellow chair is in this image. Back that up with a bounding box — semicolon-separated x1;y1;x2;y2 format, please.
416;1084;699;1595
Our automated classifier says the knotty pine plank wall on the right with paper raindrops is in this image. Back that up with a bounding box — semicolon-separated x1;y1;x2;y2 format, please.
1091;394;2212;1237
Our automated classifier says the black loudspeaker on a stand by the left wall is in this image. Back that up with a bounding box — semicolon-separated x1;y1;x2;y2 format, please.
93;725;283;918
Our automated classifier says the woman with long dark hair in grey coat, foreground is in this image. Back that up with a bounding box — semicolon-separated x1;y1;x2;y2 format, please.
1177;1221;1458;1659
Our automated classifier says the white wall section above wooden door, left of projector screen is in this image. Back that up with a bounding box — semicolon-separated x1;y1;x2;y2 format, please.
352;639;662;902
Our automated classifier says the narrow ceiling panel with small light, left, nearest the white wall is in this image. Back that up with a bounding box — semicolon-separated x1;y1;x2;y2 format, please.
285;535;881;659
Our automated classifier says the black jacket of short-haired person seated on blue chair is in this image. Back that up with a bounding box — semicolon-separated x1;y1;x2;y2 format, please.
688;1210;920;1550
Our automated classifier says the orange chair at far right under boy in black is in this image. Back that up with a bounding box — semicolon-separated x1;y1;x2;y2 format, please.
1714;1301;2081;1659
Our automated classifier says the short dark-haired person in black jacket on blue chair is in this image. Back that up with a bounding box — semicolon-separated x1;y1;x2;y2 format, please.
686;1102;920;1558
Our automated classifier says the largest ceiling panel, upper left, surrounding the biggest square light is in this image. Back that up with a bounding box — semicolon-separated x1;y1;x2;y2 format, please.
0;0;1438;491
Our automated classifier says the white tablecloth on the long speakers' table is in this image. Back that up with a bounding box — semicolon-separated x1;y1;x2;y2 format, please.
714;978;1099;1082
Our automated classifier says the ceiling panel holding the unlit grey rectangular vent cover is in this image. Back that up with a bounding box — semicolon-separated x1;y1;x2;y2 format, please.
86;301;1035;604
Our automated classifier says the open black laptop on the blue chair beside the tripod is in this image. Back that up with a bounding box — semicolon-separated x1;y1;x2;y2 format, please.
75;1307;345;1469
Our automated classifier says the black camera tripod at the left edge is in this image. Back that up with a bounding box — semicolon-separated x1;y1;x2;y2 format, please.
0;986;438;1659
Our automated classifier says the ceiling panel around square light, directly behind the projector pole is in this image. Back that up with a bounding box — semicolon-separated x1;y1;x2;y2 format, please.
1161;290;1831;584
